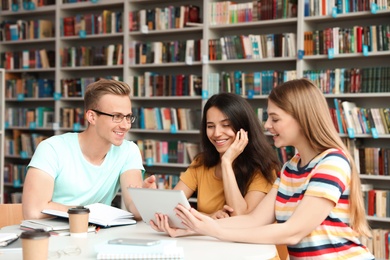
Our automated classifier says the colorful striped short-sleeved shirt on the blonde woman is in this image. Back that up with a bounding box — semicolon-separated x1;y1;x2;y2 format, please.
274;149;375;260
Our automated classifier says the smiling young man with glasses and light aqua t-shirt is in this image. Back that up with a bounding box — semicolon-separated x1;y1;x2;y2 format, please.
22;79;156;219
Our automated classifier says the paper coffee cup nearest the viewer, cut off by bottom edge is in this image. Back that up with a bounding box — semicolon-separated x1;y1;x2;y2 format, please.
20;231;50;260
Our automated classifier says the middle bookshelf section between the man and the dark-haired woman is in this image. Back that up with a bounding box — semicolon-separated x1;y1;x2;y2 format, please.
124;0;205;187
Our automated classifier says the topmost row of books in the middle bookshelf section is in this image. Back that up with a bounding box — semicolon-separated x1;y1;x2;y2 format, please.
129;5;201;32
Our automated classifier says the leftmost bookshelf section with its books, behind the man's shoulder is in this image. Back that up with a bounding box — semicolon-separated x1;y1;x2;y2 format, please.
0;5;57;203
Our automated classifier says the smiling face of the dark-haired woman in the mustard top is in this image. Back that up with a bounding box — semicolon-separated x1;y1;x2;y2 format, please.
206;107;235;155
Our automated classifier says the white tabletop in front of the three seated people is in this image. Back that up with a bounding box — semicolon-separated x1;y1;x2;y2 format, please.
0;222;276;260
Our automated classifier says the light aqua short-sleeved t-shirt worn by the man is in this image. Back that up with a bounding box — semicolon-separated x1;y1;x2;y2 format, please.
28;133;145;205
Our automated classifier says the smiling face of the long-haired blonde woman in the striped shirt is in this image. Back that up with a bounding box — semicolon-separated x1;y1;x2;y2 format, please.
264;101;303;148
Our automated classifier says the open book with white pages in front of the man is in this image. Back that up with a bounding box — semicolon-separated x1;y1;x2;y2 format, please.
42;203;137;227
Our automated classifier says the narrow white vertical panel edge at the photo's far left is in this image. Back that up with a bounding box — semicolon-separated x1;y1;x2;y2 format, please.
0;69;5;204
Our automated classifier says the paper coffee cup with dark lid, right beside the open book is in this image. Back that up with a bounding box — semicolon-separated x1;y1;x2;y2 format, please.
68;207;89;237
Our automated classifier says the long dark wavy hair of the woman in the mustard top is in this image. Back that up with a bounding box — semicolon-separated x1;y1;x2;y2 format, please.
191;93;280;196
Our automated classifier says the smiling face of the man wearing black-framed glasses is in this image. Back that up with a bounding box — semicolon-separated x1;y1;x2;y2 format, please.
94;94;132;146
